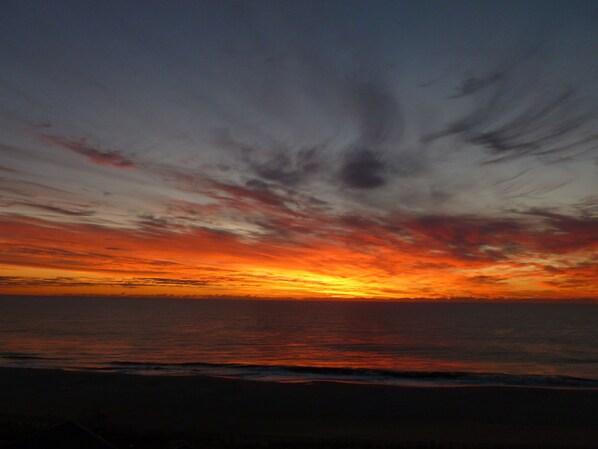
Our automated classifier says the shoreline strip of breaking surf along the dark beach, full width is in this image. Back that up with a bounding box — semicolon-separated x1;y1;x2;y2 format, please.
0;353;598;390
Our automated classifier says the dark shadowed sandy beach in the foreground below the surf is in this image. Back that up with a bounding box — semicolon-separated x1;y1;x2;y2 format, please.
0;368;598;448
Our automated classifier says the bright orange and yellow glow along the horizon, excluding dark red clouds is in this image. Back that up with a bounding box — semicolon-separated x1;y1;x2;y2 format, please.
0;212;598;300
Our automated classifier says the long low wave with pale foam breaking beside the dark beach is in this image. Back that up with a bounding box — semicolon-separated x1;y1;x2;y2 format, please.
104;361;598;388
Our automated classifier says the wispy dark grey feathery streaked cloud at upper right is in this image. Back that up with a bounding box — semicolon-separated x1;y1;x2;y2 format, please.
422;68;598;163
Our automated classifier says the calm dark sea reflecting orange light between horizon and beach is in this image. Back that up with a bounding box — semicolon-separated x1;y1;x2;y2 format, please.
0;297;598;388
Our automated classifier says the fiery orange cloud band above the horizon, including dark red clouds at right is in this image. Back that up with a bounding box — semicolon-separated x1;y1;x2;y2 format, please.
0;207;598;299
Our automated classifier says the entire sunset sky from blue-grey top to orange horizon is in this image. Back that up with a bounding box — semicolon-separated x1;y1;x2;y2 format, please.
0;0;598;300
